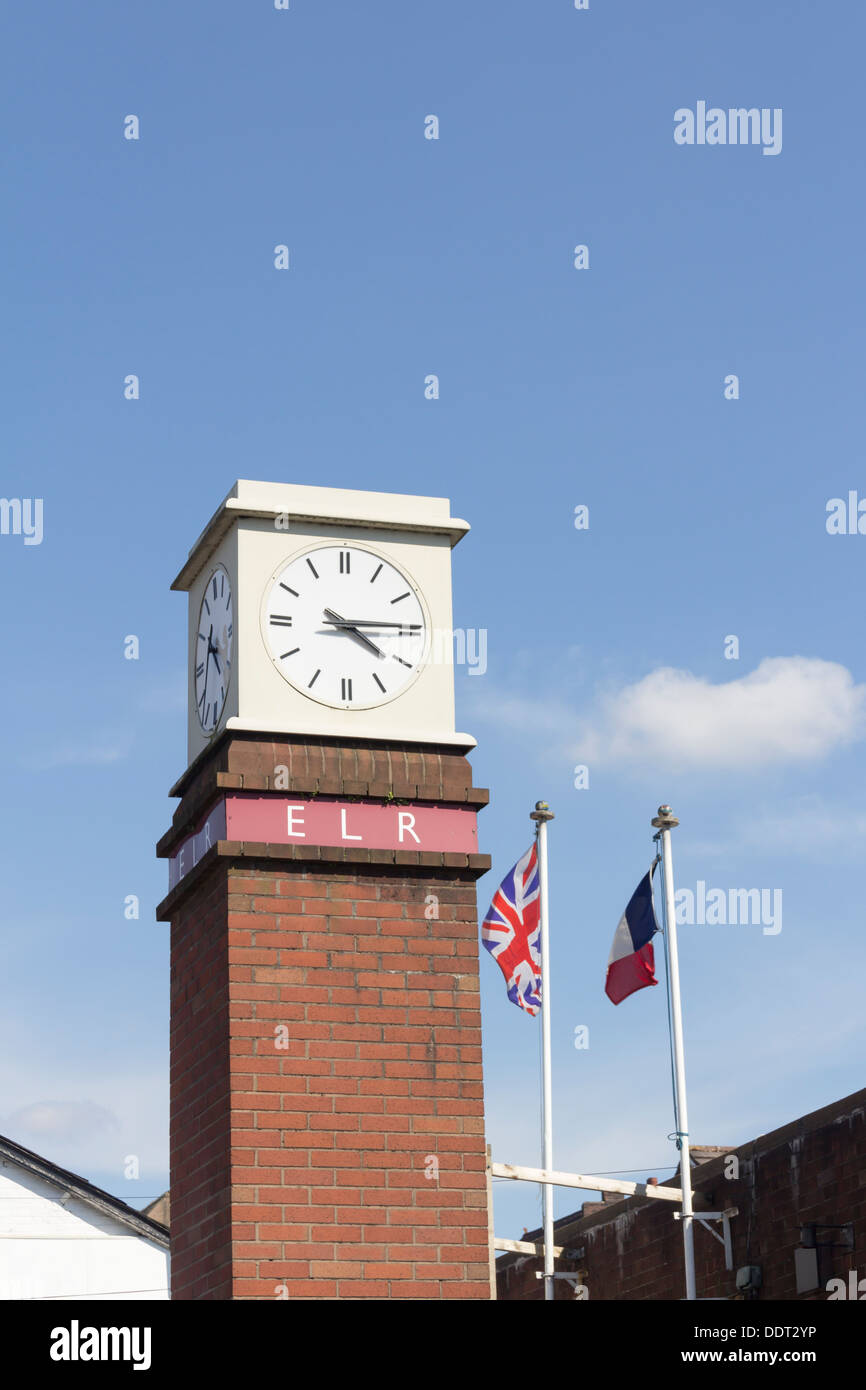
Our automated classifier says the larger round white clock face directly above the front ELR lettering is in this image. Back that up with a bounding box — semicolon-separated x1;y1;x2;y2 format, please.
261;545;428;709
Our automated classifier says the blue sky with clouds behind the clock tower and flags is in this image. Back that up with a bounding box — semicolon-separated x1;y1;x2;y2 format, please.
0;0;866;1238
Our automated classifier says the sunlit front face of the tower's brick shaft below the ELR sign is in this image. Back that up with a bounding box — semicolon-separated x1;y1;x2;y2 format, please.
228;865;489;1298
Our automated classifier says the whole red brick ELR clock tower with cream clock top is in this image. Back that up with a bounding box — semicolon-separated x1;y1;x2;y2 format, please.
157;481;492;1300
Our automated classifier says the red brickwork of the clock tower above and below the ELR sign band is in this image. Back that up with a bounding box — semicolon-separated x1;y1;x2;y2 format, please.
157;735;491;1300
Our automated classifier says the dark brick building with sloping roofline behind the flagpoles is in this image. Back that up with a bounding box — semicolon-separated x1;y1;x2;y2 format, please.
498;1091;866;1301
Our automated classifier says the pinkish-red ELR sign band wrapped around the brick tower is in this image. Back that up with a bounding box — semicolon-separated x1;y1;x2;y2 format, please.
168;795;478;888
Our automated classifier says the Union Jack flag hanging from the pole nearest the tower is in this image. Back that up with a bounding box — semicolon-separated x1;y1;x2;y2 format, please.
481;844;541;1016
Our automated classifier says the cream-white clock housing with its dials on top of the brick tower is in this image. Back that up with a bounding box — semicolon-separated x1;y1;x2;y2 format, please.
172;480;474;762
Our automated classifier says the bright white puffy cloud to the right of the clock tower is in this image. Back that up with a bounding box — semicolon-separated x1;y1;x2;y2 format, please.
575;656;866;767
